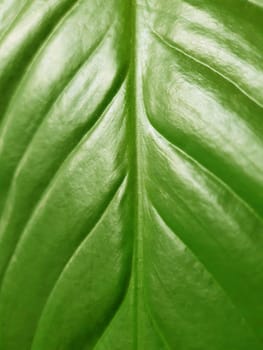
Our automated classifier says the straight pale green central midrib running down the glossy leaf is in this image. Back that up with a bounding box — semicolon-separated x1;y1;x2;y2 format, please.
127;0;143;350
